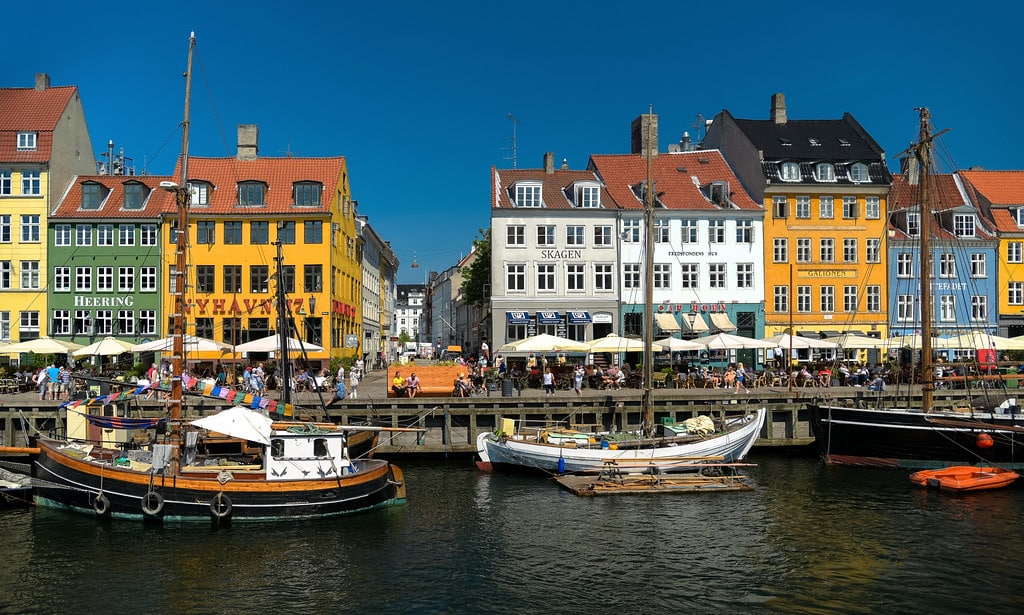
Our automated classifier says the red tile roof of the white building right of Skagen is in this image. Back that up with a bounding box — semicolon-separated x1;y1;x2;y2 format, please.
590;149;763;211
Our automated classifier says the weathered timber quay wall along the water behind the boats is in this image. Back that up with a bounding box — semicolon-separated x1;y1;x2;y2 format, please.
0;364;946;456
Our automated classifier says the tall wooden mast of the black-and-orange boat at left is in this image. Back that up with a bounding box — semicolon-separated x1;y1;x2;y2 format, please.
170;32;196;474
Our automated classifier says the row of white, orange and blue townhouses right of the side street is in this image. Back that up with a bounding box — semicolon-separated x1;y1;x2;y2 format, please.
489;94;1024;364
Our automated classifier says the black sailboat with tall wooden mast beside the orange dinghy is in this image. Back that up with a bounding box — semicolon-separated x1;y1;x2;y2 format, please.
808;108;1024;470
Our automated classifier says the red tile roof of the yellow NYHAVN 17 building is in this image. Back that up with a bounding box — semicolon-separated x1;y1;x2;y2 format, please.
174;156;345;216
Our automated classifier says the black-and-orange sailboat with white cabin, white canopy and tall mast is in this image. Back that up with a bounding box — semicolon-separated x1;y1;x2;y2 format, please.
4;34;406;523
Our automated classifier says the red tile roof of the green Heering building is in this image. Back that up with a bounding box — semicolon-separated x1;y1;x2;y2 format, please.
50;175;174;218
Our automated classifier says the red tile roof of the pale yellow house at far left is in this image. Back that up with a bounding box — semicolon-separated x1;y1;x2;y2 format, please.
0;86;78;163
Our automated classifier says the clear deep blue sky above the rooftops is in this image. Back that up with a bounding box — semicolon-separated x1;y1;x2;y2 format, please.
8;0;1024;283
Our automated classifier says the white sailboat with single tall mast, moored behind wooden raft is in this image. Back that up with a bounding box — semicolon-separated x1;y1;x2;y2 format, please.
476;110;767;474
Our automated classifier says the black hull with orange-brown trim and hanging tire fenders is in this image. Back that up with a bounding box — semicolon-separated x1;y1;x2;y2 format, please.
33;441;406;523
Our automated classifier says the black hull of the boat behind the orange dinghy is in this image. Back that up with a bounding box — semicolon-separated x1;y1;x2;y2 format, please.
807;404;1024;470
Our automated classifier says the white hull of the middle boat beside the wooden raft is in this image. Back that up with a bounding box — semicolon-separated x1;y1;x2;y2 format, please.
476;408;766;474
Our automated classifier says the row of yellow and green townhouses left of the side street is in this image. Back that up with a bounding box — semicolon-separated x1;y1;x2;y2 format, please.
0;75;398;366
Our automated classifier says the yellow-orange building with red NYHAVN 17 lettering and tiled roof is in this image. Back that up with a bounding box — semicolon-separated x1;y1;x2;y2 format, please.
162;126;361;369
